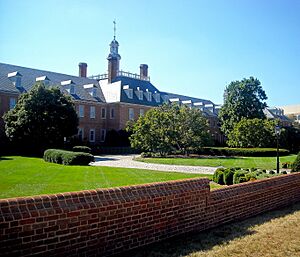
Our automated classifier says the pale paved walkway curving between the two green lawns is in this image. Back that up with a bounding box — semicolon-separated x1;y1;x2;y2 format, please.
91;155;216;174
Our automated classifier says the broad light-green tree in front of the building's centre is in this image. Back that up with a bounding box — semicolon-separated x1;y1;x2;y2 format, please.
127;105;210;155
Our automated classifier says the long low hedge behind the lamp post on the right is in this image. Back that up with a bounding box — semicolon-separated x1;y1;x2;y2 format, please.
198;147;289;157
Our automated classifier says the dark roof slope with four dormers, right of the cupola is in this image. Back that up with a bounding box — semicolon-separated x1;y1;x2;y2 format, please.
112;76;163;106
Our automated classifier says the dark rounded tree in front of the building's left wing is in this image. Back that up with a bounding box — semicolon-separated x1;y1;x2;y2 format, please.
3;84;78;152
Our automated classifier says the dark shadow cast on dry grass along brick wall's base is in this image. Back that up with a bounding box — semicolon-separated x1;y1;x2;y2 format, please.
115;203;300;257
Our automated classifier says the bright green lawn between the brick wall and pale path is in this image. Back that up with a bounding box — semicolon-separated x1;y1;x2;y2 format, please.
0;156;213;198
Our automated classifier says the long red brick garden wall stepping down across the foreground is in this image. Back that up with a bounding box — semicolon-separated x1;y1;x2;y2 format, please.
0;174;300;256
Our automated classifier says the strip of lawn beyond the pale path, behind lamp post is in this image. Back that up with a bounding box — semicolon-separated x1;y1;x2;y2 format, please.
136;155;297;170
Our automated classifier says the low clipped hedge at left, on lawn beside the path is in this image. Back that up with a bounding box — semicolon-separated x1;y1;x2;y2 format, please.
44;149;94;165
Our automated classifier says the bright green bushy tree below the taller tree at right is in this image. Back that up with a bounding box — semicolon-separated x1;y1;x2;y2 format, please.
227;118;277;148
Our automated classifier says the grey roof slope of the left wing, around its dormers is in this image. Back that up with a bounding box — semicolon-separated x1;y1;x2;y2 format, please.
0;63;105;102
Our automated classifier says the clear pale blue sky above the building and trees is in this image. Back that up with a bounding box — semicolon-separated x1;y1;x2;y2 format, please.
0;0;300;107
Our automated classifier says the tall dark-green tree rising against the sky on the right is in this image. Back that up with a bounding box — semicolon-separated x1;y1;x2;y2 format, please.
219;77;267;136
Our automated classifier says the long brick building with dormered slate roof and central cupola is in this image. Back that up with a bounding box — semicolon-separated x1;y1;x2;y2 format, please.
0;36;222;144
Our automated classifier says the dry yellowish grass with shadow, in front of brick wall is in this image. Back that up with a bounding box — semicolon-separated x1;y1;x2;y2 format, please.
117;203;300;257
